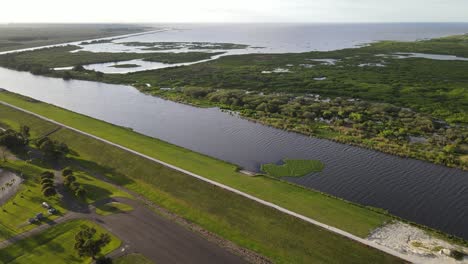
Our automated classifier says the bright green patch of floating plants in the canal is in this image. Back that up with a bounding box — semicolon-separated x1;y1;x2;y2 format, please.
262;159;324;177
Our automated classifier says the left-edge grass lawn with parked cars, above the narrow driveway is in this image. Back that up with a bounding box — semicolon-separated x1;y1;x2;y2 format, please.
0;161;66;240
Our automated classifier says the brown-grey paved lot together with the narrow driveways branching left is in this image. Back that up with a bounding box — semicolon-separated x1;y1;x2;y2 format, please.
0;182;246;264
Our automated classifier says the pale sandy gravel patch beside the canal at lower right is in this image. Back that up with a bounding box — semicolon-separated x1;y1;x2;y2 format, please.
367;222;468;264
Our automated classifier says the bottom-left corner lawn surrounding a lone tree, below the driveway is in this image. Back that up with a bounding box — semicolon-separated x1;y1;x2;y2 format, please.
0;220;121;264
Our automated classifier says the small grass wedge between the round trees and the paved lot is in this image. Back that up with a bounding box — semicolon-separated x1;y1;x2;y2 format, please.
73;171;133;203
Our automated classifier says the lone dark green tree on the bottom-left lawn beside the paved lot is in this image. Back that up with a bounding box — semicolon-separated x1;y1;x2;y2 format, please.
74;225;111;260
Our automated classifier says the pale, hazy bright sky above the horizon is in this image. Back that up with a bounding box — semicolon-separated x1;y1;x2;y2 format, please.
0;0;468;23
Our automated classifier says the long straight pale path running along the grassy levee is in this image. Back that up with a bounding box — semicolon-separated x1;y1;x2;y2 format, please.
0;101;417;263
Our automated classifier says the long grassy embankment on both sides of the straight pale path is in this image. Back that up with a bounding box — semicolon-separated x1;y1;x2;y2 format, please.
0;93;399;263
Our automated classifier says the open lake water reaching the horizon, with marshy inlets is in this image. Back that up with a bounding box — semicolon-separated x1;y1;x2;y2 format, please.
14;23;468;73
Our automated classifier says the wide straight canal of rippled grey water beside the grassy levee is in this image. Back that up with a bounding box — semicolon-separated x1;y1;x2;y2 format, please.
0;68;468;239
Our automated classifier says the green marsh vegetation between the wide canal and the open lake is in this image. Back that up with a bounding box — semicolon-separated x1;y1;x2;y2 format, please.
0;35;468;169
